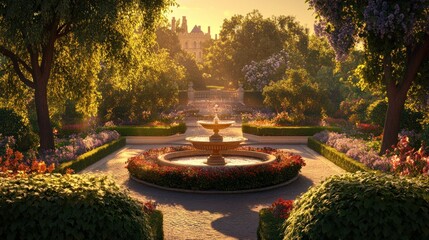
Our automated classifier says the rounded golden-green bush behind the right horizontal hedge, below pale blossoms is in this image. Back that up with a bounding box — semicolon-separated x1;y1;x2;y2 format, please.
262;69;323;123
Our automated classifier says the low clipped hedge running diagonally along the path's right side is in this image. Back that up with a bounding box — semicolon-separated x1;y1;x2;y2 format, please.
307;137;373;172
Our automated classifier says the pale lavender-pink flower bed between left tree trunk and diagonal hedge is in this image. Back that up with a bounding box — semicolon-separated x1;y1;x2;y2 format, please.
41;130;119;165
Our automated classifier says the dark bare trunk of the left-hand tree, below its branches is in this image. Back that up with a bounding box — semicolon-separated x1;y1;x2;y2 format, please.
35;80;55;152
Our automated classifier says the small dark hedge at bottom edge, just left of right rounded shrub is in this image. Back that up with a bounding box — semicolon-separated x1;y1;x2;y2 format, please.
257;208;284;240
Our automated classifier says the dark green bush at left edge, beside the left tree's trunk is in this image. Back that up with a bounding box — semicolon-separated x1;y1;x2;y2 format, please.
0;108;37;152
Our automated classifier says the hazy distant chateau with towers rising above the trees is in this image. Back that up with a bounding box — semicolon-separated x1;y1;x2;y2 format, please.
171;16;211;62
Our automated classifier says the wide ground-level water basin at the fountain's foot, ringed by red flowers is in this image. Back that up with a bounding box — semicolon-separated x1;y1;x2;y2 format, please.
157;150;276;168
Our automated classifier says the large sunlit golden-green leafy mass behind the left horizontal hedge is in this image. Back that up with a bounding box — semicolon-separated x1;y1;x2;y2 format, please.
99;48;184;124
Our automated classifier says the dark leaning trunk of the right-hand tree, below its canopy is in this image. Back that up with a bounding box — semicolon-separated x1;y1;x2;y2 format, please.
380;94;406;154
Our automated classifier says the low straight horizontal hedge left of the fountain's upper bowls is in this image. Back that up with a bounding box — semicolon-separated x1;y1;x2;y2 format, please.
107;123;186;136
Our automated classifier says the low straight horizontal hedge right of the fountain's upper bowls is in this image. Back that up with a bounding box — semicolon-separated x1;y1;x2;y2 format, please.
241;124;341;136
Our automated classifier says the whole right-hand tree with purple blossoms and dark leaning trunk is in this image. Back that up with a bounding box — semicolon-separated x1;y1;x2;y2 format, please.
307;0;429;153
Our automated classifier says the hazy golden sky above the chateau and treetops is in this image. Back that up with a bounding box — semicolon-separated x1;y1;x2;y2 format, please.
167;0;315;38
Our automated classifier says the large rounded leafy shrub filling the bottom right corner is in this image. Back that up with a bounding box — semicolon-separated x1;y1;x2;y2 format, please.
284;173;429;240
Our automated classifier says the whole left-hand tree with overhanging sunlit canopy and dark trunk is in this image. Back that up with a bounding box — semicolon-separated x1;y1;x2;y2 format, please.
0;0;171;151
